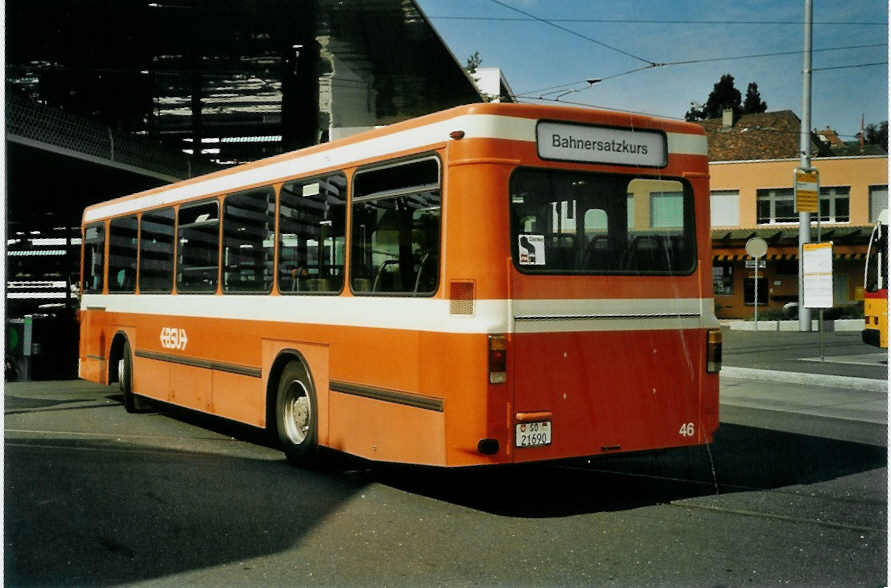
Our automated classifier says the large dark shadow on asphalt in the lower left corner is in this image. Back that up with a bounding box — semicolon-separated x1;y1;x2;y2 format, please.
4;437;363;586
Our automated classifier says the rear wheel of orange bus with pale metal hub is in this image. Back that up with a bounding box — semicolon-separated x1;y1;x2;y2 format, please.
275;362;319;466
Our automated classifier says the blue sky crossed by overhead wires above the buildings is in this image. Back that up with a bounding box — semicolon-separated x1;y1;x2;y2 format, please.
417;0;888;140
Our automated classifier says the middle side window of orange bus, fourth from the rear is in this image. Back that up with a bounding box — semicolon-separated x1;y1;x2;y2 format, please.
176;200;220;293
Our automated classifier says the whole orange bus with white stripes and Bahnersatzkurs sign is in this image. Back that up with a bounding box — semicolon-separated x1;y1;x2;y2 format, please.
78;104;721;467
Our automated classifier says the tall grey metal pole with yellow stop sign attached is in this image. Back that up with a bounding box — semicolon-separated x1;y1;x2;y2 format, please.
798;0;820;332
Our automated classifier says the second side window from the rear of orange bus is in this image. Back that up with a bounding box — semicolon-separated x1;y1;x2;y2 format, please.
278;172;347;294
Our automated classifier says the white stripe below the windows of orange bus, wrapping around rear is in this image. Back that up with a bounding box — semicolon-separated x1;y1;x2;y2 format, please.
81;294;718;334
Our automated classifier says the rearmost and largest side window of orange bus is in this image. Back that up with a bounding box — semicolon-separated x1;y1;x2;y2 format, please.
350;157;441;296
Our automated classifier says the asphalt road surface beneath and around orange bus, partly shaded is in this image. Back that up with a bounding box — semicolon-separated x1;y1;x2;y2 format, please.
4;354;887;586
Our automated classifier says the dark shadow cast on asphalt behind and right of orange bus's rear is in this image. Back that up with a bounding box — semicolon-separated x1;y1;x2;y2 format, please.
370;424;887;518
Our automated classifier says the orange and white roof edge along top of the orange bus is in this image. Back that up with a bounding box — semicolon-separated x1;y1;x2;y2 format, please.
83;103;707;223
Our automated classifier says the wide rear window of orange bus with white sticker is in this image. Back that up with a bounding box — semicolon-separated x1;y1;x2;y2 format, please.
510;169;696;275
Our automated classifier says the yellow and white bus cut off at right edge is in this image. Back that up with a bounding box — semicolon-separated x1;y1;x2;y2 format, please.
860;209;888;349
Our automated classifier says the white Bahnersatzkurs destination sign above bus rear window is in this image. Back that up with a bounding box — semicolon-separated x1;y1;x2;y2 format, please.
536;121;668;167
